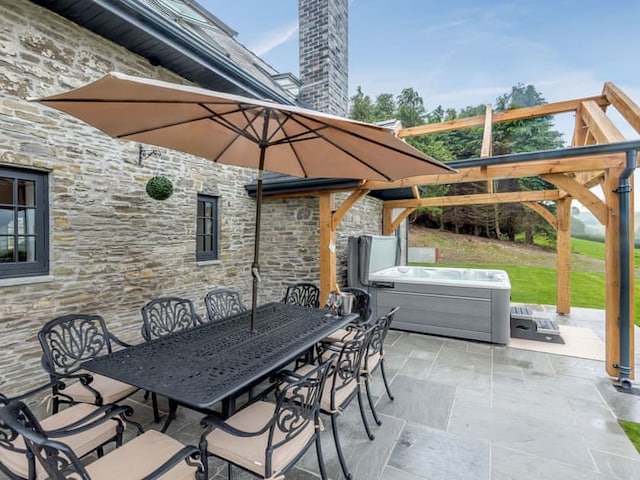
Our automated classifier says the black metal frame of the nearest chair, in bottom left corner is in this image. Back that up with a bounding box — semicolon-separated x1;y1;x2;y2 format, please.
0;401;205;480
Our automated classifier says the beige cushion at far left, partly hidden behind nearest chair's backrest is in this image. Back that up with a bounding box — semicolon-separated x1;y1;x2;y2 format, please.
0;403;118;479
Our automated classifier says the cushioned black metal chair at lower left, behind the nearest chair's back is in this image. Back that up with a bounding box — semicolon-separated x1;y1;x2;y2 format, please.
0;381;127;480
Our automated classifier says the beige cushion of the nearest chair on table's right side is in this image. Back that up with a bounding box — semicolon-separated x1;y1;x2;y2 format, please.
207;402;315;477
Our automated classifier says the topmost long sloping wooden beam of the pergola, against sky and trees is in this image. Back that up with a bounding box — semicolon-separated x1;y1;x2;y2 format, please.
398;95;609;138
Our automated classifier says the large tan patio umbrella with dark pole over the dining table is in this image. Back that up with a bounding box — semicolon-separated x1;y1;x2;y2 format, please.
34;72;451;330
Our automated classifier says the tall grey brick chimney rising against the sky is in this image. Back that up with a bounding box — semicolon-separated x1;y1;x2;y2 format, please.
298;0;349;117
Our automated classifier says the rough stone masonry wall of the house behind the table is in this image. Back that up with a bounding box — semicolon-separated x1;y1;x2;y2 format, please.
0;0;382;395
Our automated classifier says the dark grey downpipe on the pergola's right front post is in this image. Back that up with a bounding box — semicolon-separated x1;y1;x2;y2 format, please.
613;149;637;392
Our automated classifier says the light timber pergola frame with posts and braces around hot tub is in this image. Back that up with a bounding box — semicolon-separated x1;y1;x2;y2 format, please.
292;83;640;378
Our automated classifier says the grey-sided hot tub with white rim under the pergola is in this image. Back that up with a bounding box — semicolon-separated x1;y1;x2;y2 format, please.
369;266;511;344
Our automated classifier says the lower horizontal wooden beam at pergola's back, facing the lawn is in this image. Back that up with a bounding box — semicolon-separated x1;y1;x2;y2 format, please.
383;190;560;210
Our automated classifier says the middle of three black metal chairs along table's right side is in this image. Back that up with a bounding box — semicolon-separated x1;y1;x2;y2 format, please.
317;325;375;480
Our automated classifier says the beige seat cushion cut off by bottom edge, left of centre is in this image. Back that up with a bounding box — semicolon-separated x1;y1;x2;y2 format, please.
87;430;196;480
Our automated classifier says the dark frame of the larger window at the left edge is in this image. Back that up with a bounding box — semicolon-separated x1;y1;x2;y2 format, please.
0;165;50;280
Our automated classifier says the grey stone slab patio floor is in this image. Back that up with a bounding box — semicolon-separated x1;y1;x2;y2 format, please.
6;308;640;480
